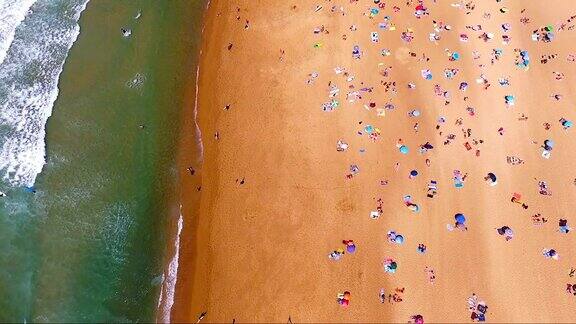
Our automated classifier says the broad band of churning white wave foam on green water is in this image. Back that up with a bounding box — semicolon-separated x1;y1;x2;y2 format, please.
0;0;88;186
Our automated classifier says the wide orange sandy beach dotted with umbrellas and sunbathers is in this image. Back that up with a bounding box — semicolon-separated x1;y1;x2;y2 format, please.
172;0;576;323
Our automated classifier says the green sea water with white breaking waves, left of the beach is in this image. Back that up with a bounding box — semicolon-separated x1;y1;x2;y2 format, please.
0;0;203;321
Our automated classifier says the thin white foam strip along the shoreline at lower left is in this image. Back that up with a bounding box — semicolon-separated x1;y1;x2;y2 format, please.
158;205;184;323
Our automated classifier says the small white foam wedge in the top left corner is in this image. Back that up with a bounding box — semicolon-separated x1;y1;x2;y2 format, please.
0;0;36;64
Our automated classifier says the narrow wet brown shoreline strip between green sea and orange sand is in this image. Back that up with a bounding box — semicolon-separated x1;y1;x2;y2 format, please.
156;0;210;323
